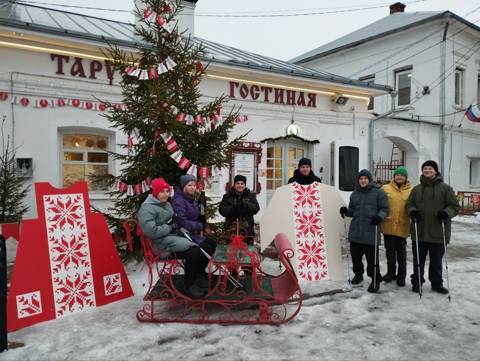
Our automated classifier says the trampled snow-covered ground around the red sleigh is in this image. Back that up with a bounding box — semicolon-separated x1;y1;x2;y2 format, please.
0;217;480;360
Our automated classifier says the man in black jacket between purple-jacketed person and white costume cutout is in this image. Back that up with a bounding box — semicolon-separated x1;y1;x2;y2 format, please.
219;174;260;244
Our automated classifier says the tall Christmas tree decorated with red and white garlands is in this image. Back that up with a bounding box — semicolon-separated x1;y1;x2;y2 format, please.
102;0;239;255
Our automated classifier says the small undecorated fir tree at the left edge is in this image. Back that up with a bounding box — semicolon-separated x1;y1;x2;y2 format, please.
0;116;29;223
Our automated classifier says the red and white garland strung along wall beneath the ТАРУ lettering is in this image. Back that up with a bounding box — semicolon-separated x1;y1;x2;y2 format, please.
0;91;128;112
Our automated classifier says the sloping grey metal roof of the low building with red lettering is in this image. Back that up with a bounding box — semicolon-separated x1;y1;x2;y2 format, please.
0;3;390;91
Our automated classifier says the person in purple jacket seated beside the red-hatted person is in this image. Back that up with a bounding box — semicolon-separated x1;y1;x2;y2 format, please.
172;174;217;254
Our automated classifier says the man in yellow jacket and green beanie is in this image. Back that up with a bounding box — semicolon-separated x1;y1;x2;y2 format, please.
382;167;412;287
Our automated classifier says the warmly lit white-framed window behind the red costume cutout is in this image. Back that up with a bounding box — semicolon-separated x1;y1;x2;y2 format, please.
61;132;110;192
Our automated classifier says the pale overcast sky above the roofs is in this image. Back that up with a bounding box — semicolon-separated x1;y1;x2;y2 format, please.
27;0;480;60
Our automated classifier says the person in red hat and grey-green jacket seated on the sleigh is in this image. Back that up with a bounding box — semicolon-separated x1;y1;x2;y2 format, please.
138;178;208;298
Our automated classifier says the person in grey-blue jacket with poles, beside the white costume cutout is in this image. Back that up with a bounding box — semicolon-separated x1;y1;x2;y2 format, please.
340;169;388;292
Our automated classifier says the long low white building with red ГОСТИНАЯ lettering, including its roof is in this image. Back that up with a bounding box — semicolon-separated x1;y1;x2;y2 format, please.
0;1;389;217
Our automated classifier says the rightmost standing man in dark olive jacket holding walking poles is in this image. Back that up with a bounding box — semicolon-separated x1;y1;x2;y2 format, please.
405;160;460;294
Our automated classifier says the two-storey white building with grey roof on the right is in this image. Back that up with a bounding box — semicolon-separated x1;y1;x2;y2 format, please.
291;3;480;191
